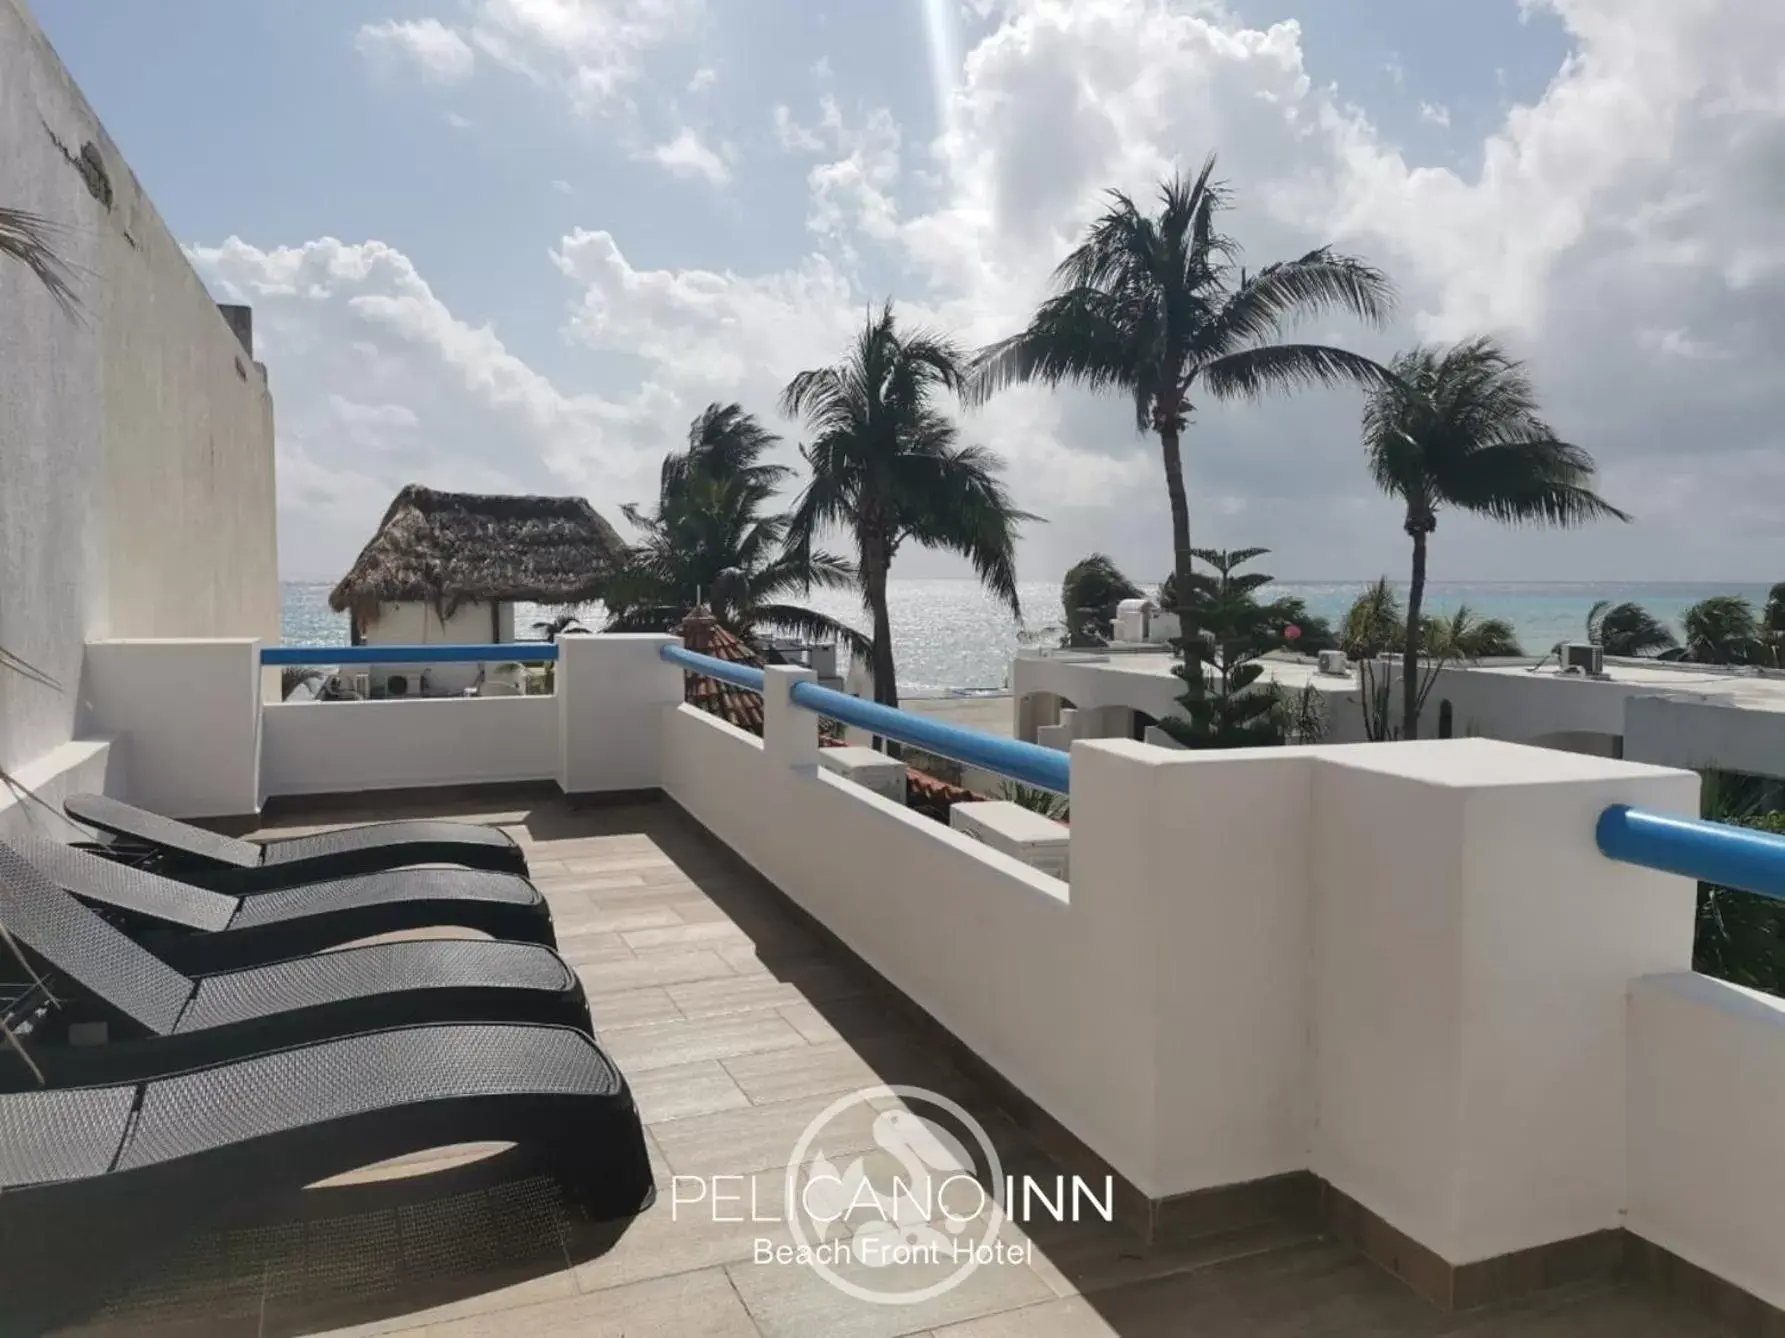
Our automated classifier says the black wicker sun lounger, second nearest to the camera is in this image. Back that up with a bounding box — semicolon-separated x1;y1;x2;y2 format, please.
0;846;591;1088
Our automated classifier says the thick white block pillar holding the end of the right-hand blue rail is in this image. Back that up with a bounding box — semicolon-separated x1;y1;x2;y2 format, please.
1310;739;1698;1263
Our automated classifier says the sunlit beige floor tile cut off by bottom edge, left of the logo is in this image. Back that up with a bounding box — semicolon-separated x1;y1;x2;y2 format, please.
428;1268;757;1338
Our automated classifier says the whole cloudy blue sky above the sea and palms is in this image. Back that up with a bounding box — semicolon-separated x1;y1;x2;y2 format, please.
34;0;1785;580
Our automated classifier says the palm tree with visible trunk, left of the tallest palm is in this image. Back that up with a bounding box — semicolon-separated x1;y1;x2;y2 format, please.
782;301;1037;706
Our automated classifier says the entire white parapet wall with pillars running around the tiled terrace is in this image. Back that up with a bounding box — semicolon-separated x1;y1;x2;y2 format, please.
66;637;1785;1301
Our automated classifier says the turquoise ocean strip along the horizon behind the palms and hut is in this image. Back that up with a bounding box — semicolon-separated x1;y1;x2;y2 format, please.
282;580;1769;696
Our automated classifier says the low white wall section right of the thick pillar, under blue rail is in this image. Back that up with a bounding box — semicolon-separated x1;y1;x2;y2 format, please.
1628;972;1785;1308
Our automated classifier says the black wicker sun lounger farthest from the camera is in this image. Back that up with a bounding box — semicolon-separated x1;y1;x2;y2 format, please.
62;794;527;892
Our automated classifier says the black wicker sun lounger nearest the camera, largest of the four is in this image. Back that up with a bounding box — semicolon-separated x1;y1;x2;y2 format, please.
0;1024;653;1333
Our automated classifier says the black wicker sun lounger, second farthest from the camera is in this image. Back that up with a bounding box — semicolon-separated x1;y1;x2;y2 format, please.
16;837;557;970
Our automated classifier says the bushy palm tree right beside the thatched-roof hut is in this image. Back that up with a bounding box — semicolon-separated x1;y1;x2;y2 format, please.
602;405;868;663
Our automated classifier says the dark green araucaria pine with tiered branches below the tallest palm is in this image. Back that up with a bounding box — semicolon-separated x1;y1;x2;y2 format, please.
1158;548;1287;747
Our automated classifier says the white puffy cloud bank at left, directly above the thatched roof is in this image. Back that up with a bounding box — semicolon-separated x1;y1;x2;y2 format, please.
187;237;671;573
